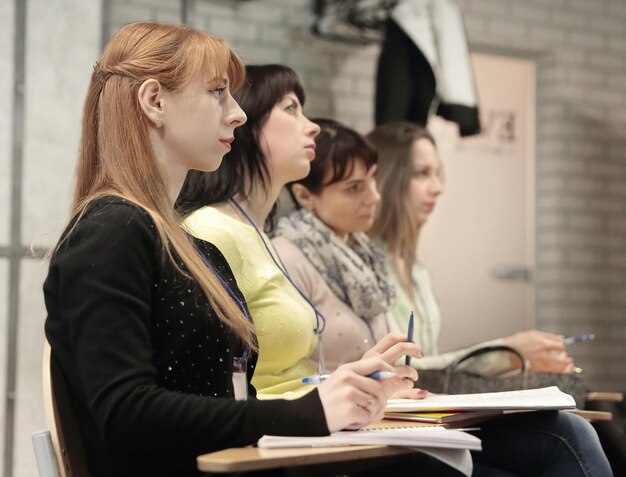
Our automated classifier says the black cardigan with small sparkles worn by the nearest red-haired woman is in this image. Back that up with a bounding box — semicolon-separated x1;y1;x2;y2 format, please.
44;196;328;476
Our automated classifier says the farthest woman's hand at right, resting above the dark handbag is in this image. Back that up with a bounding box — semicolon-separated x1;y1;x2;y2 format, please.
504;330;574;373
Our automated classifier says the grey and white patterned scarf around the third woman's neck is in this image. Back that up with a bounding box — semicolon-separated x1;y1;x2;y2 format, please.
276;209;395;320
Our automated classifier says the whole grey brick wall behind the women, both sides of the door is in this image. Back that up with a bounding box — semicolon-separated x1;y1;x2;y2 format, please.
105;0;626;389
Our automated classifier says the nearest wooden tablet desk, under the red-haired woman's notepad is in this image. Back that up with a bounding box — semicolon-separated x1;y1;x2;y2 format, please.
197;446;415;473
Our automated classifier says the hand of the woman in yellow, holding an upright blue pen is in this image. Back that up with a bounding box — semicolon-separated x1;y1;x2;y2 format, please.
361;333;423;398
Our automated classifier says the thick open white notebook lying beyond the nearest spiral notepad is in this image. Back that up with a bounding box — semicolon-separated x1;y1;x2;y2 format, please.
385;386;576;412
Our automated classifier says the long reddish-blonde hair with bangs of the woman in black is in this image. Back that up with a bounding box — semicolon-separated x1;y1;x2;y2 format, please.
64;22;255;347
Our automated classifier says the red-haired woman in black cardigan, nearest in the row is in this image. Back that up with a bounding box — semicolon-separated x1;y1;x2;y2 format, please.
44;23;404;477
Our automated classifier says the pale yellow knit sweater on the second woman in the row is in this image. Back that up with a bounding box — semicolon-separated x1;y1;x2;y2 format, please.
183;207;317;399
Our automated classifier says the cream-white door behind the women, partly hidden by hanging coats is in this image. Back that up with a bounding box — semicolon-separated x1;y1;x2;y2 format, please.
418;54;535;351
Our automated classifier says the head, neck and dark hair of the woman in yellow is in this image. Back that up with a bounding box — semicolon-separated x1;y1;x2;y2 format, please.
177;65;306;225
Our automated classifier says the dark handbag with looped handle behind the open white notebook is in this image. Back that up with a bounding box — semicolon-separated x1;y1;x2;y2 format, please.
417;345;586;409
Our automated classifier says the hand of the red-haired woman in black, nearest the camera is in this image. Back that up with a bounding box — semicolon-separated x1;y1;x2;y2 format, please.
317;358;404;432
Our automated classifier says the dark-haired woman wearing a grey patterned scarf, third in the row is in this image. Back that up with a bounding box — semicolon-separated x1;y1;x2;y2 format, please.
272;119;398;369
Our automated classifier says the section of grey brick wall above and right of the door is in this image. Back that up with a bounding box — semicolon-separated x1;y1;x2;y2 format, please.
448;0;626;389
